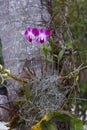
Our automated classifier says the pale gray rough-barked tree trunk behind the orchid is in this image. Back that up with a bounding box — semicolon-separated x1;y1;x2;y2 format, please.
0;0;50;120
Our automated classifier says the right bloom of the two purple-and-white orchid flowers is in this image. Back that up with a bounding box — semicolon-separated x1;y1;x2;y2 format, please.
36;29;50;44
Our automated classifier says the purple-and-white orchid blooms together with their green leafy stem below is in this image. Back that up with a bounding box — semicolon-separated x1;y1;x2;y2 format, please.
24;27;52;70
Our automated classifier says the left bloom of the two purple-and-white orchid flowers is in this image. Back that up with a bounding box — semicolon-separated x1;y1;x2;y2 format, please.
24;27;39;42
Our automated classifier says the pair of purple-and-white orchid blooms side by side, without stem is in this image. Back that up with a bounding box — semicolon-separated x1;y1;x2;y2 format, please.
24;27;51;44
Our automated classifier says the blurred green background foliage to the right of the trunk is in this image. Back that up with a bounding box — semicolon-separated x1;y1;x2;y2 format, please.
53;0;87;124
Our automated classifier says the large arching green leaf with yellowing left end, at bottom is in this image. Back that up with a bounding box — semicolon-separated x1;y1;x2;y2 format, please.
32;111;83;130
